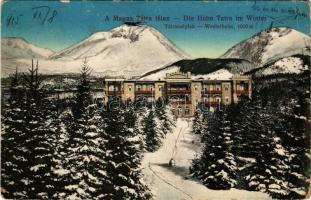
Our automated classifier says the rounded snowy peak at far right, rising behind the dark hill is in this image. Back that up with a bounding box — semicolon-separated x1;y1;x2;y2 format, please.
222;27;311;67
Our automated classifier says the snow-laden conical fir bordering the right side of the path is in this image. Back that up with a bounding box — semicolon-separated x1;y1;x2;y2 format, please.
190;110;237;189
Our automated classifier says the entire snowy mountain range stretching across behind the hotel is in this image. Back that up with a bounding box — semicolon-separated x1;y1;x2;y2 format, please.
1;24;311;77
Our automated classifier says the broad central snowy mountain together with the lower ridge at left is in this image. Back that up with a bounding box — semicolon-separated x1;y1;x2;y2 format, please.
1;24;189;77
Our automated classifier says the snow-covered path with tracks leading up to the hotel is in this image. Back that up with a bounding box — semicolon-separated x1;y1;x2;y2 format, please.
142;119;270;200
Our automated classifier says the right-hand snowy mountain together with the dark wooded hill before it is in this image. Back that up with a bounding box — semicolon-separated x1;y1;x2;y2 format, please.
142;27;311;79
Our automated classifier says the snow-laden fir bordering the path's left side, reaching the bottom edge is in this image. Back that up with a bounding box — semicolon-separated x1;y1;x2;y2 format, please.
102;101;151;200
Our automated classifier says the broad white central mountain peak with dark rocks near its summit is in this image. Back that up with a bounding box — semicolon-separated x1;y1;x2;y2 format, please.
50;24;188;75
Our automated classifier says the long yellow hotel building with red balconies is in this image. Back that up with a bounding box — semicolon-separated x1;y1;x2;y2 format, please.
104;72;252;117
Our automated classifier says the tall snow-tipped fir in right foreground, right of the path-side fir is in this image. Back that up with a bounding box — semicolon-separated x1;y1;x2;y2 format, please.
239;99;290;199
